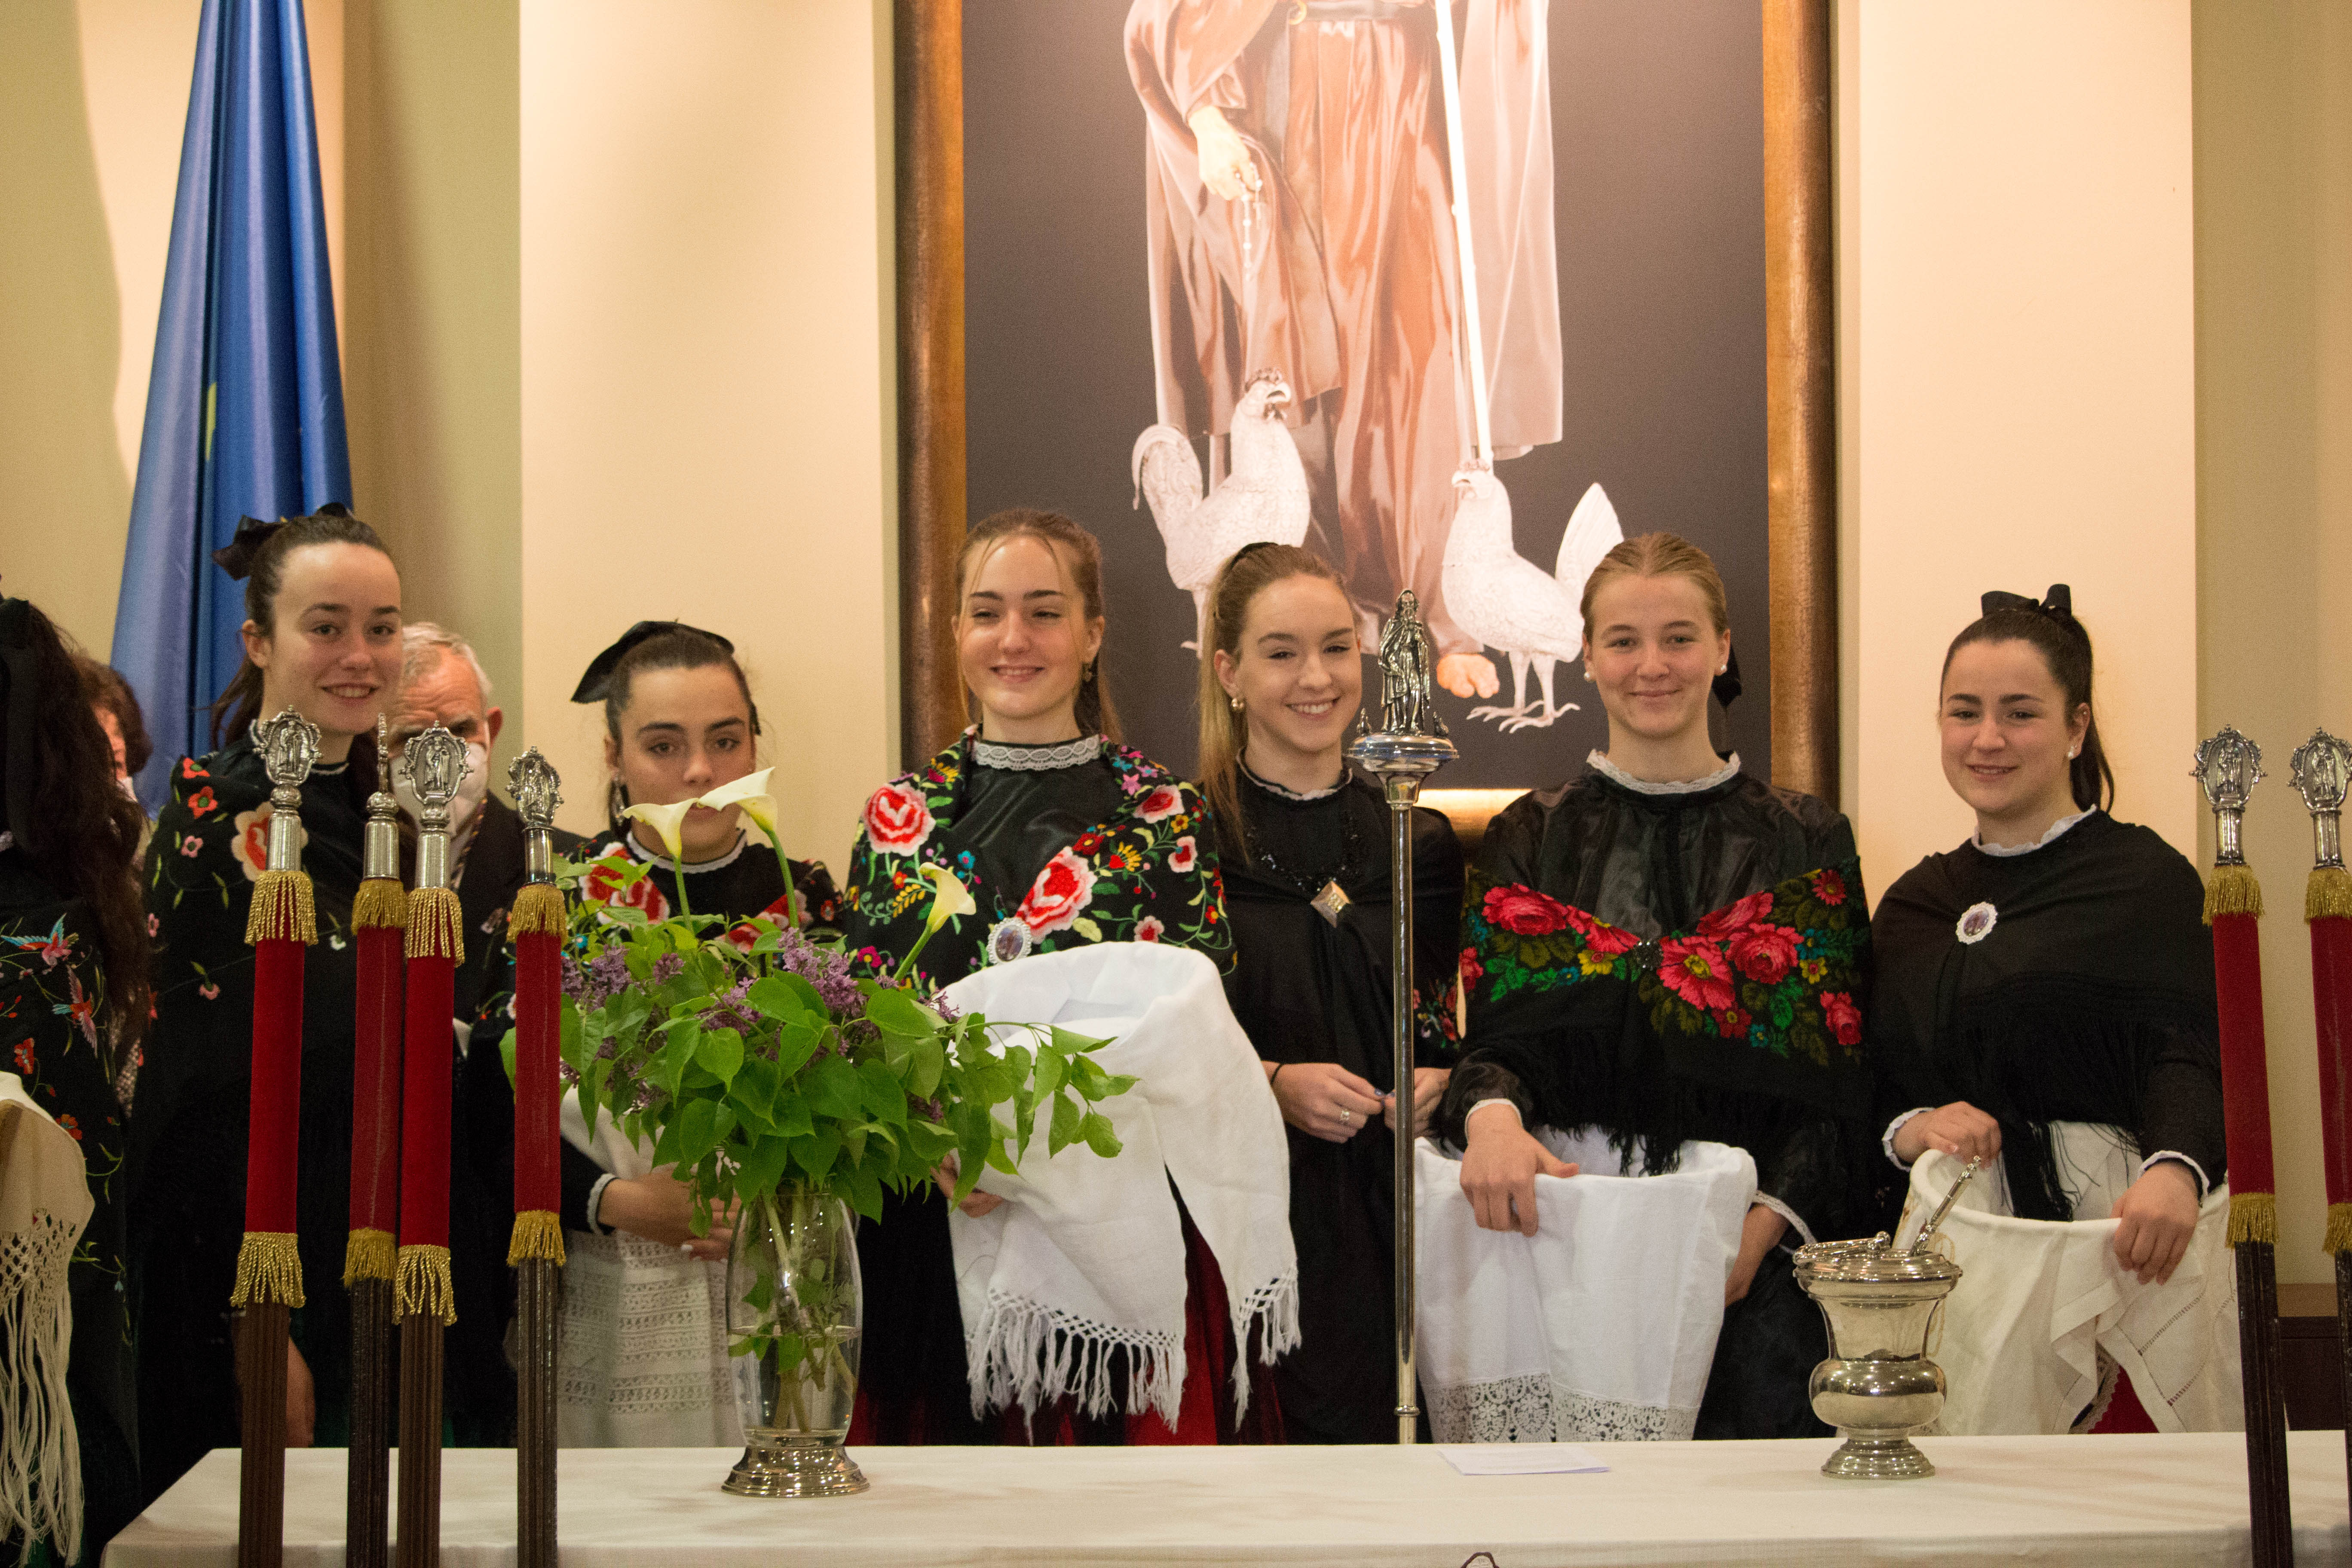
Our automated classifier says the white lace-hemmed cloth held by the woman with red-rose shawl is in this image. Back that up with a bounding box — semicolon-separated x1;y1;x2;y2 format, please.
1414;1128;1757;1443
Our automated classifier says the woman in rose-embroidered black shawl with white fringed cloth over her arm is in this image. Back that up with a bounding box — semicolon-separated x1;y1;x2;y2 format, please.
844;510;1272;1443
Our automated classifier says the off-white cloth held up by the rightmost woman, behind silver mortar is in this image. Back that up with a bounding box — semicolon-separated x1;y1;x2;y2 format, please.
1898;1121;2246;1436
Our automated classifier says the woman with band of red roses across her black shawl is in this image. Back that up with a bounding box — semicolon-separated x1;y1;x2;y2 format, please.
1437;534;1870;1436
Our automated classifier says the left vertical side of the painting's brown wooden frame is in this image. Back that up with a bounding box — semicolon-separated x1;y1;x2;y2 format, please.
896;0;965;766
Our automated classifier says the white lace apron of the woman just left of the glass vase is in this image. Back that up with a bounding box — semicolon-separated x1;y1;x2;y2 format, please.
555;1093;743;1448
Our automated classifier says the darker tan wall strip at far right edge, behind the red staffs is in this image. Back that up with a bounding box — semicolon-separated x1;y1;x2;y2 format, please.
2194;0;2352;1281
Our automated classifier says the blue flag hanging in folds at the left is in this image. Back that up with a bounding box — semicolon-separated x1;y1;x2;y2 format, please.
113;0;350;811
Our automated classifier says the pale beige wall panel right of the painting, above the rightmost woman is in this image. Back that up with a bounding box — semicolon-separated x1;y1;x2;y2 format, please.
1839;0;2197;888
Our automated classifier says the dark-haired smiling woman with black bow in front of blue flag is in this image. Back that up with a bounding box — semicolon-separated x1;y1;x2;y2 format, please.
127;505;423;1498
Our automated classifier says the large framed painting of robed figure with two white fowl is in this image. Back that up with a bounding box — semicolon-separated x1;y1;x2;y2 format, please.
898;0;1837;846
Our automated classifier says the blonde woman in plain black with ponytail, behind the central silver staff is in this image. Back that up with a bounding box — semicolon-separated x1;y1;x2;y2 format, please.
1200;545;1463;1443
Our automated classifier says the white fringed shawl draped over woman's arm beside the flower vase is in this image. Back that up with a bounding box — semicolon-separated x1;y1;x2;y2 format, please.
946;943;1298;1427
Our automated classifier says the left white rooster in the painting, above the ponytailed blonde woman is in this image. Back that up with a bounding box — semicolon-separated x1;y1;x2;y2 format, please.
1134;371;1308;646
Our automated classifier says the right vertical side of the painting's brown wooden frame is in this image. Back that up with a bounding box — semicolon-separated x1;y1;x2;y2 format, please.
1764;0;1837;806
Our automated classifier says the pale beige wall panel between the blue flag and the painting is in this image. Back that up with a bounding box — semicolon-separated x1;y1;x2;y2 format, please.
522;0;896;872
